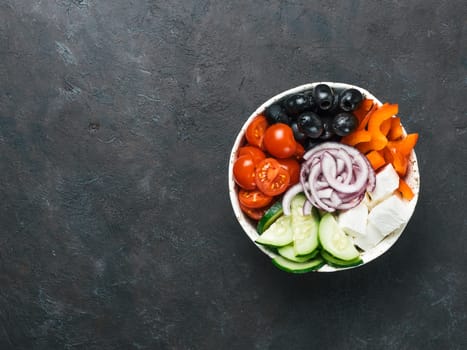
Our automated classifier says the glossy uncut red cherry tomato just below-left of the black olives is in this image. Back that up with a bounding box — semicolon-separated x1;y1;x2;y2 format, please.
264;123;297;158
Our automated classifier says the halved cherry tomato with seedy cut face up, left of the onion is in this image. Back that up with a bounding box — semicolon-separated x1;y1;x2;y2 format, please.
256;158;290;196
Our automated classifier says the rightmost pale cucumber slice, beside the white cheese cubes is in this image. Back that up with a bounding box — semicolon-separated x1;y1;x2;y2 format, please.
318;213;360;261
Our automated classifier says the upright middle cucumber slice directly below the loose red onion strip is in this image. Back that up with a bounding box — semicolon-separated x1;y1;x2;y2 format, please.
292;204;320;256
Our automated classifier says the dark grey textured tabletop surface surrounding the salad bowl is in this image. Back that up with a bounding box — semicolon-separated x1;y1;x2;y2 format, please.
0;0;467;350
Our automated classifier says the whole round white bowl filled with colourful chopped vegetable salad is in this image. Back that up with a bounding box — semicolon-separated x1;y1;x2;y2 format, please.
229;82;420;273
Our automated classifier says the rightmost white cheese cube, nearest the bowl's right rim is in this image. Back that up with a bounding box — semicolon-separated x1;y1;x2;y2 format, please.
368;194;410;236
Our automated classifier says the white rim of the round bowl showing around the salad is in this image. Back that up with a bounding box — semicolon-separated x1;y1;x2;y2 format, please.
229;82;420;272
